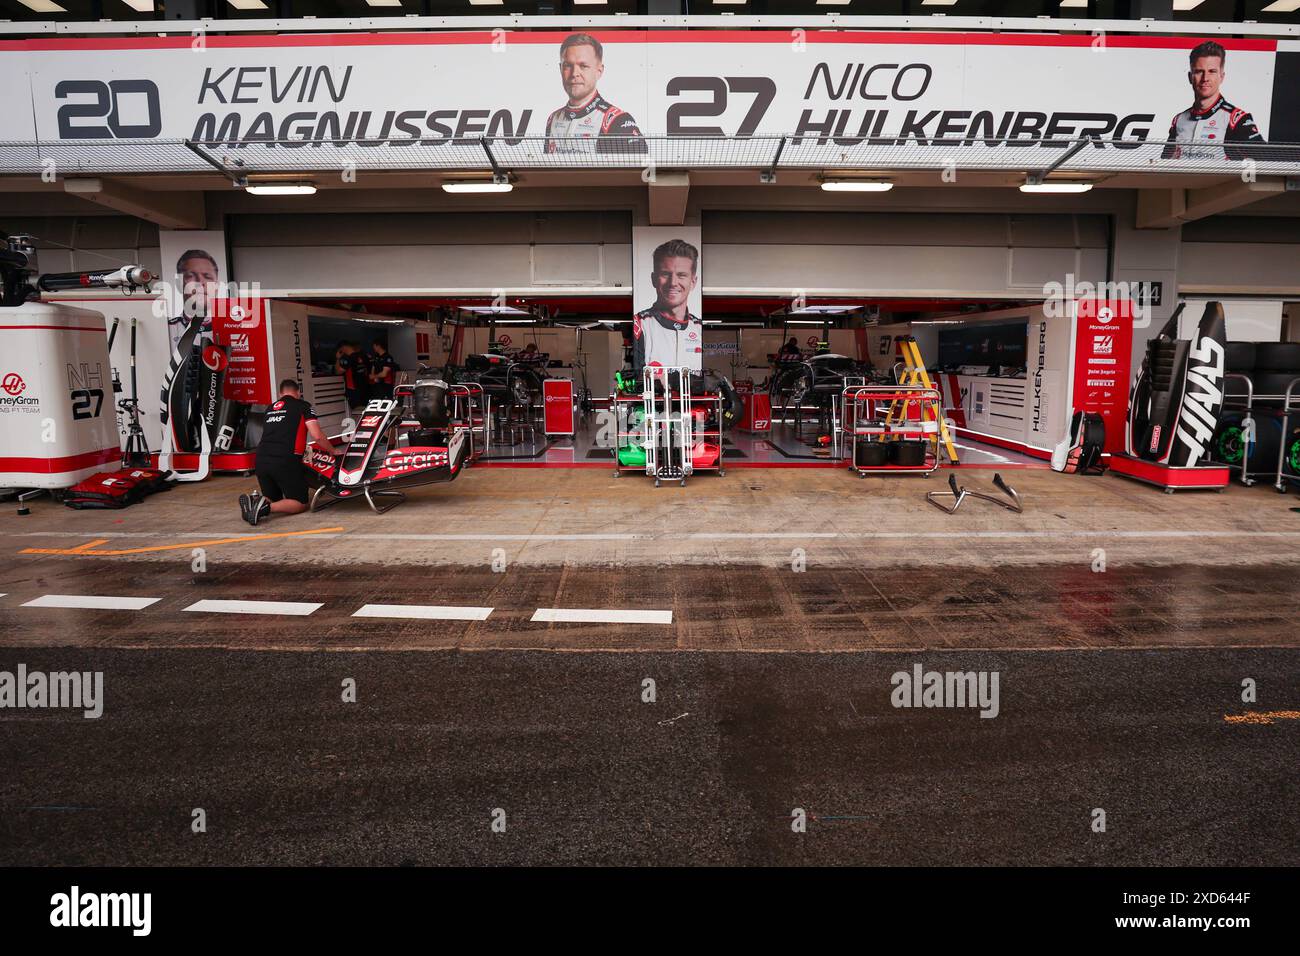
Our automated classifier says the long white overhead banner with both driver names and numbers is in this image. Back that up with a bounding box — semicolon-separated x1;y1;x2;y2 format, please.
0;30;1300;152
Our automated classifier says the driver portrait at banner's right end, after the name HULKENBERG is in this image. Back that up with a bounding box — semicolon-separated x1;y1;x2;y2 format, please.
1161;40;1265;160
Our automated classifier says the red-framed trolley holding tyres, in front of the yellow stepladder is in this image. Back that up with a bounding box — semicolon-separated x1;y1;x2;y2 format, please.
840;385;943;477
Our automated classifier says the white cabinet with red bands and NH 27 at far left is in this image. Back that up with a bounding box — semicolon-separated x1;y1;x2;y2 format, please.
0;303;122;488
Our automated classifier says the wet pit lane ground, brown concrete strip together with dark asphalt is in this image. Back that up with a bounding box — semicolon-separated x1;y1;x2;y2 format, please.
0;555;1300;865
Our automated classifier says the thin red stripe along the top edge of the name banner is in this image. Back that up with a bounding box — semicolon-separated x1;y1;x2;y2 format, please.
0;31;1278;53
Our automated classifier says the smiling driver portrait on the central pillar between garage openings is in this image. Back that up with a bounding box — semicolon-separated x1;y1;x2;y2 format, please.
632;239;705;368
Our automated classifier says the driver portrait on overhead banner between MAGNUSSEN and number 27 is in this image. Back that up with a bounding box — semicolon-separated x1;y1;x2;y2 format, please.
546;34;646;153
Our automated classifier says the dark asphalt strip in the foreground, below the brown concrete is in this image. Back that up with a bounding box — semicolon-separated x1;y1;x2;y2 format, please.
0;648;1300;865
